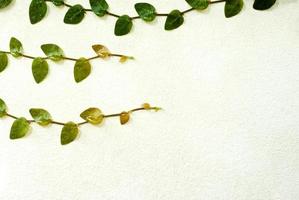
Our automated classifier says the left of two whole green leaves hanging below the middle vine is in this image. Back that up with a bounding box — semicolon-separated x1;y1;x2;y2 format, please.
32;58;49;83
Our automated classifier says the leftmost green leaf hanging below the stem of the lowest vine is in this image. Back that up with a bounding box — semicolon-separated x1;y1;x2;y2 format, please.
10;117;30;140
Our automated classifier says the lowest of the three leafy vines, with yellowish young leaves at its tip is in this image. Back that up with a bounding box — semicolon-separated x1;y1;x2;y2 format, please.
0;98;161;145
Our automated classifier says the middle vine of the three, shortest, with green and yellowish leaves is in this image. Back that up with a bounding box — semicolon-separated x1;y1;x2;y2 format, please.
0;37;133;83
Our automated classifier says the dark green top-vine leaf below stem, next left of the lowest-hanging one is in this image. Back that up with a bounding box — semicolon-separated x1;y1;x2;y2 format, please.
64;4;85;24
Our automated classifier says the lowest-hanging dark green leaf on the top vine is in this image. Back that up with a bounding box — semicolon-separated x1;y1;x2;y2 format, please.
114;15;133;36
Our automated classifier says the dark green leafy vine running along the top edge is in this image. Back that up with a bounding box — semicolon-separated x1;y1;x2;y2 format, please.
22;0;276;36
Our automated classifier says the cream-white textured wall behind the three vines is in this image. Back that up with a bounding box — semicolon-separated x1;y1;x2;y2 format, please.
0;0;299;200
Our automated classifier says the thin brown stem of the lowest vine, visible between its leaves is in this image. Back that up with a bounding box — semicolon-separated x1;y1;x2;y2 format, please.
6;107;161;126
